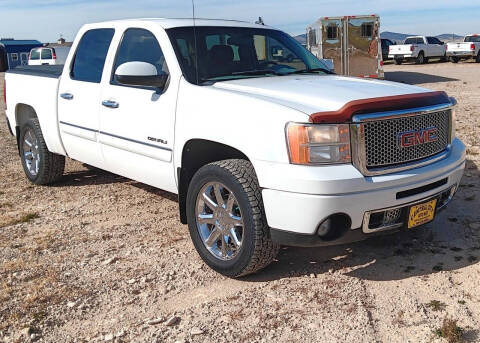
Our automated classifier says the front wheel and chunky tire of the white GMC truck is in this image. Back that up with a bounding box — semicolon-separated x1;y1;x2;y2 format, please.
187;159;279;277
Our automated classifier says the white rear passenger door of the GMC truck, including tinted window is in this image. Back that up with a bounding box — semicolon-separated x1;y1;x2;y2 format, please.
58;28;115;167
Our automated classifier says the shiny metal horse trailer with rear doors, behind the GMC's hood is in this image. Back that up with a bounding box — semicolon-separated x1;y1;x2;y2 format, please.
307;15;384;78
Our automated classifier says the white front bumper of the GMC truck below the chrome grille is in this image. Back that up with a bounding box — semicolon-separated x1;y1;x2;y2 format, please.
255;139;465;246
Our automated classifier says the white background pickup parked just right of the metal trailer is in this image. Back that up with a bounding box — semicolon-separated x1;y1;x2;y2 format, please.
388;36;446;64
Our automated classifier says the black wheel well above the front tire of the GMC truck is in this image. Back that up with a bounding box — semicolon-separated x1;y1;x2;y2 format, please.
177;139;248;224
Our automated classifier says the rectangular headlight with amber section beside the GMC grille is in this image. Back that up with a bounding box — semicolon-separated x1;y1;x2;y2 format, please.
287;123;352;164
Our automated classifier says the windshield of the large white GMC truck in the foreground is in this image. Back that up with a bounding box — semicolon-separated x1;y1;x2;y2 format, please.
167;26;329;84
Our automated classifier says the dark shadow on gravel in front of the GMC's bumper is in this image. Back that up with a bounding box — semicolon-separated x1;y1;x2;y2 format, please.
245;160;480;282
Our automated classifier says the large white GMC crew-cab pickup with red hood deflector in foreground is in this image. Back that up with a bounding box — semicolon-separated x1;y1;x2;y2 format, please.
2;19;465;277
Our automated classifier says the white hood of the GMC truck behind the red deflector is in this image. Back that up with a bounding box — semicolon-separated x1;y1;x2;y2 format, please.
213;75;429;115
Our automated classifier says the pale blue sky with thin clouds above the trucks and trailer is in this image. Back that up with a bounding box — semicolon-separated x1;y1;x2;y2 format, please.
0;0;480;42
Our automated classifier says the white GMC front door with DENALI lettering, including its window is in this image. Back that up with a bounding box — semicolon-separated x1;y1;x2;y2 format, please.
99;28;177;192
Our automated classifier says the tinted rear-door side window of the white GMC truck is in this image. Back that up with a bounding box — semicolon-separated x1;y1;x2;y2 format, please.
70;29;115;83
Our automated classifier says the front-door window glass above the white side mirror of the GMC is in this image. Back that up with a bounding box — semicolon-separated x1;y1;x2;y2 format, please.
111;29;168;84
